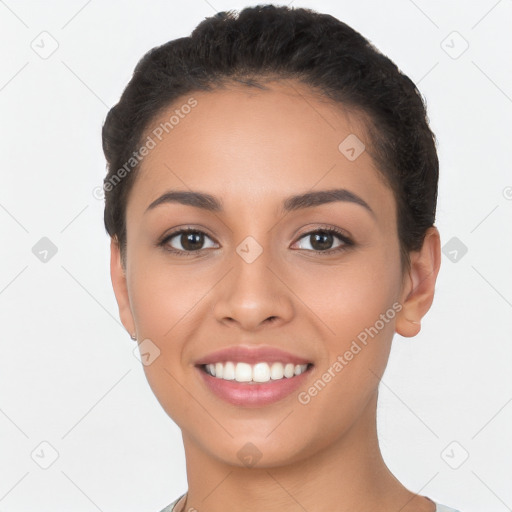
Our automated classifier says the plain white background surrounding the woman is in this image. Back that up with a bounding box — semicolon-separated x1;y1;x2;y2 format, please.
0;0;512;512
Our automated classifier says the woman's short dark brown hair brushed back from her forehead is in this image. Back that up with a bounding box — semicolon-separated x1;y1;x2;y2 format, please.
102;5;439;264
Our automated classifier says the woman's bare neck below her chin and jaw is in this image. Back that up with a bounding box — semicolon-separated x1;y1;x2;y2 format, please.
178;393;435;512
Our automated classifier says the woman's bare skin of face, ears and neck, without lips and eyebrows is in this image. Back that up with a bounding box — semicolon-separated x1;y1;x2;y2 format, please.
111;81;440;512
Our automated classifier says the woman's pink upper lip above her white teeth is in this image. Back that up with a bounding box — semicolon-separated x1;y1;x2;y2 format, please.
195;345;311;365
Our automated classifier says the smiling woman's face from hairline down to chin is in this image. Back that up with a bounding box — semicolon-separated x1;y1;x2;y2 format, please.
112;82;428;467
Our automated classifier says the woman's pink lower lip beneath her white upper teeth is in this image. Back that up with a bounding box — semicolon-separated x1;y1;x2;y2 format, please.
196;366;312;407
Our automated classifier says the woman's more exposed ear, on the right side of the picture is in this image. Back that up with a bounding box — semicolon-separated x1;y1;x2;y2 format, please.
395;226;441;338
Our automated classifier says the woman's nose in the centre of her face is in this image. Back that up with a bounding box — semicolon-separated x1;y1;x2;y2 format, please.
213;244;295;331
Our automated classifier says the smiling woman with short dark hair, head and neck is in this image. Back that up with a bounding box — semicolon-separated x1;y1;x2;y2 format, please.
103;5;460;512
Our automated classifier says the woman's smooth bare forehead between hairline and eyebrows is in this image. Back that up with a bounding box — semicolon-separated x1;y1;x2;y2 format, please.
128;82;394;222
